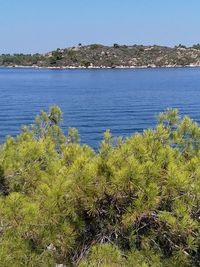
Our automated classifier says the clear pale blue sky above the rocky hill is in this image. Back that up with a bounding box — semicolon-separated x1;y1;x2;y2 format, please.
0;0;200;53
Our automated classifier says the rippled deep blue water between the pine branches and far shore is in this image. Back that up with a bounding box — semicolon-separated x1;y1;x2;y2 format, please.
0;68;200;148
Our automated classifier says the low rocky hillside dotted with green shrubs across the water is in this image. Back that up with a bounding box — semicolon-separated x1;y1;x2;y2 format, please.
0;44;200;68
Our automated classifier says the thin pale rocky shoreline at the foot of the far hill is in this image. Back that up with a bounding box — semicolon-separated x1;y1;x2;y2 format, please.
0;64;200;70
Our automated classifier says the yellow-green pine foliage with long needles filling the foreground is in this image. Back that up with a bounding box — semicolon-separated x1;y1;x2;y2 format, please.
0;106;200;267
